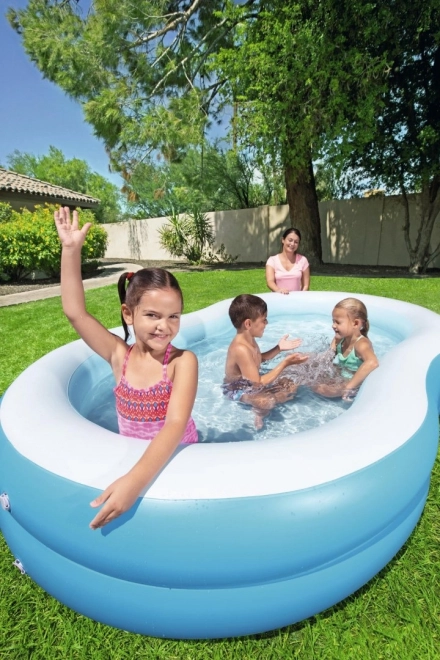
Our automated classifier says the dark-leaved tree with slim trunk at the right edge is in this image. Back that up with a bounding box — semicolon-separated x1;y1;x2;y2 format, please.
333;0;440;273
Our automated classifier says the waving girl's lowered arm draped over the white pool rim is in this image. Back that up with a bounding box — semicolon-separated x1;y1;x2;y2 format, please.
90;351;198;529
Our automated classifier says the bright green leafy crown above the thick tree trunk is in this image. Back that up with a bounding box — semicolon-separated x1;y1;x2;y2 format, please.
216;0;392;171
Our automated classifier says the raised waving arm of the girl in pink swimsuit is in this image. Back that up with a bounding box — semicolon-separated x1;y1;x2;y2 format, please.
54;207;125;363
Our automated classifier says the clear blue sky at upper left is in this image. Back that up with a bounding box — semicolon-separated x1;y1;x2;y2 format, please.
0;0;123;187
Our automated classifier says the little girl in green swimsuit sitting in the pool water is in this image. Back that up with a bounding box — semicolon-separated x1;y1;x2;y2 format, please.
313;298;379;401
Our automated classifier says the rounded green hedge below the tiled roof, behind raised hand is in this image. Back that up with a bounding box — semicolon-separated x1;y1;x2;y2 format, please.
0;205;107;280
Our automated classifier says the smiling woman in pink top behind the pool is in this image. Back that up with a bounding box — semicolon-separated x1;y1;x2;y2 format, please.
266;227;310;294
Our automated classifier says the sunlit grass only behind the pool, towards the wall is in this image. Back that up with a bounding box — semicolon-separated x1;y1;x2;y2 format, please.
0;269;440;393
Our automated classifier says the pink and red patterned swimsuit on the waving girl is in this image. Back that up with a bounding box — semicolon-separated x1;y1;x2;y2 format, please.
113;344;198;444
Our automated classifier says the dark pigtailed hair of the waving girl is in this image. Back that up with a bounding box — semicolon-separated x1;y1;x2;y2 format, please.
118;268;183;341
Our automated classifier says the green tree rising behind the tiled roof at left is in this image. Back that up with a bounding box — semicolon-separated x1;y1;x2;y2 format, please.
7;146;122;222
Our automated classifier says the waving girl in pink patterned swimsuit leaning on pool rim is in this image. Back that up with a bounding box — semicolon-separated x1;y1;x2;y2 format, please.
55;207;198;529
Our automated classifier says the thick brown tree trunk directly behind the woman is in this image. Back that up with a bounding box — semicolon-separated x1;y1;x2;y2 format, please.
284;160;322;266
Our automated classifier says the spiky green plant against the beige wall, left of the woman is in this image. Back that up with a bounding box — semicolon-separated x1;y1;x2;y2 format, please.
159;208;238;264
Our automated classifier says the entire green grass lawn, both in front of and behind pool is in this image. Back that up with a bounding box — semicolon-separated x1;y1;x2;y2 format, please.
0;269;440;660
